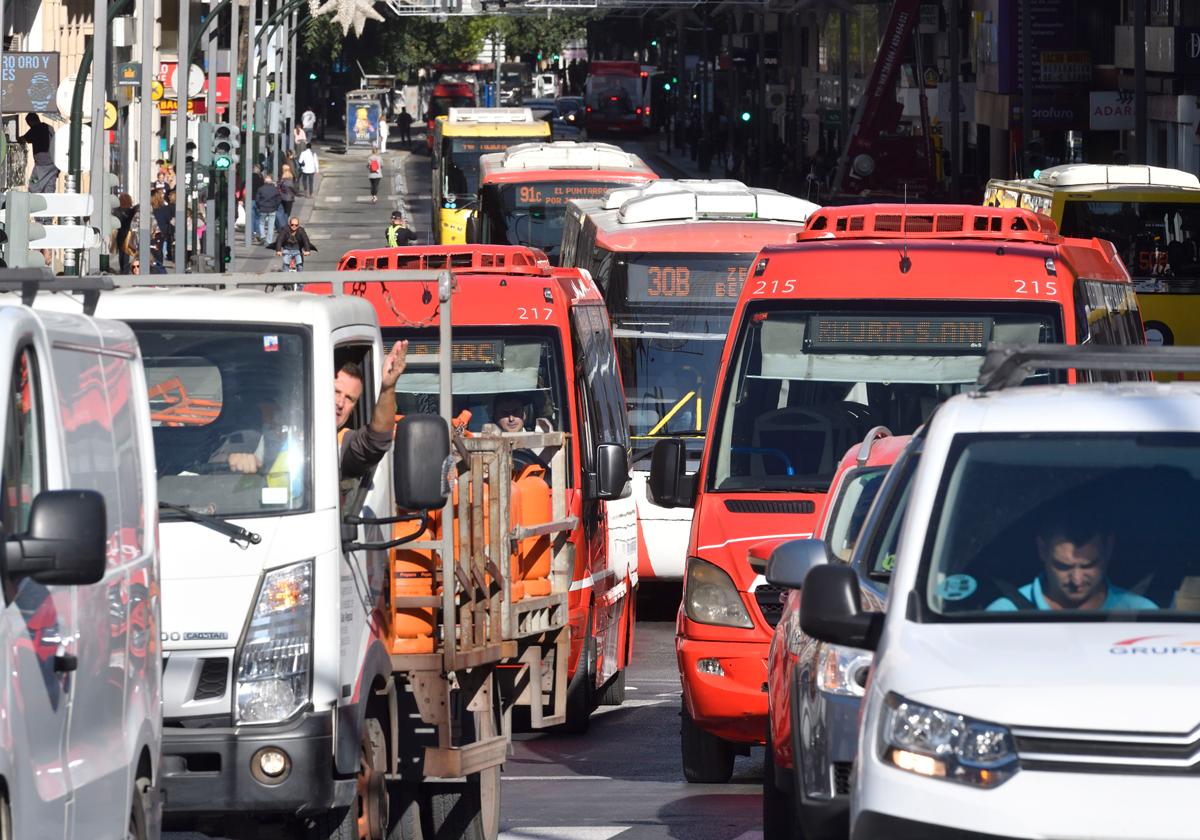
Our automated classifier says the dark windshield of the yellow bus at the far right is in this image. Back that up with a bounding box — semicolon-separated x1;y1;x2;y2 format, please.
1061;200;1200;281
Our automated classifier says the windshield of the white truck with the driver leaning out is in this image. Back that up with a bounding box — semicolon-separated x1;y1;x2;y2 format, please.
132;323;312;517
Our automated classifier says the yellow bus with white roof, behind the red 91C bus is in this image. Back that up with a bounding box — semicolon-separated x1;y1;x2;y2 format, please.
431;108;550;245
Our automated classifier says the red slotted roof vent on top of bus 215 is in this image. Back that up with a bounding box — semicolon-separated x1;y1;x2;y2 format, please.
796;204;1058;244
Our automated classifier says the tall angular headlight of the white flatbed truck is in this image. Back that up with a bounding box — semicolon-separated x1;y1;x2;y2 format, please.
238;560;312;724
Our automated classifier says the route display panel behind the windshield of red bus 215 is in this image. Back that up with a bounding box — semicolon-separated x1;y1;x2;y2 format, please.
804;314;992;354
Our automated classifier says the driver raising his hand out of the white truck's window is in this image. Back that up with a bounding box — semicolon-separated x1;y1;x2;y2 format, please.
228;341;408;479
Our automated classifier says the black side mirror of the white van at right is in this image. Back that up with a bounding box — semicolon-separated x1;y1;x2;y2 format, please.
800;564;883;650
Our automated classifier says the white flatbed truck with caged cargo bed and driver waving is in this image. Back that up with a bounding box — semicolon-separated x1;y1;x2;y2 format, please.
84;271;574;840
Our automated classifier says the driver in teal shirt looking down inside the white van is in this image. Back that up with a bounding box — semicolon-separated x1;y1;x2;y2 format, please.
988;510;1158;612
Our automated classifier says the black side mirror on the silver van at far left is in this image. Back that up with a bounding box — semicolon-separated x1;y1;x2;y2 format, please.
4;490;108;586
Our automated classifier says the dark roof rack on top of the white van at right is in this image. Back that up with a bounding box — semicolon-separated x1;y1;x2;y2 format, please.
976;343;1200;391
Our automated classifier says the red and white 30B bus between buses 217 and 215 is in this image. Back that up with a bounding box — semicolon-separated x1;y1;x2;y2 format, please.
562;180;817;581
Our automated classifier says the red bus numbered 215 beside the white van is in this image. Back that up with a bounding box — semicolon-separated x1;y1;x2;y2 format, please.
649;204;1145;781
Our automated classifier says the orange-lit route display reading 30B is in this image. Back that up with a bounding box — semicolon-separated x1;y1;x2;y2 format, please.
625;254;754;306
